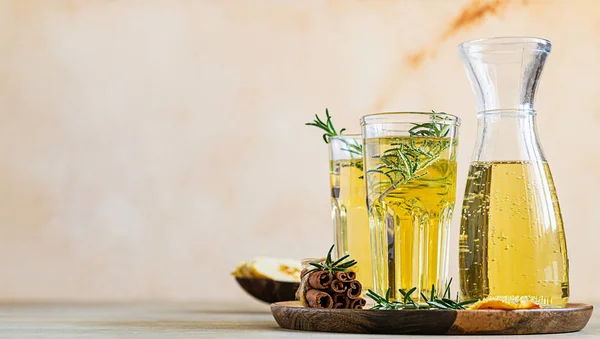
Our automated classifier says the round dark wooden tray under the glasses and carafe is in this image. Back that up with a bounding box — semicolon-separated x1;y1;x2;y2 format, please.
271;301;593;334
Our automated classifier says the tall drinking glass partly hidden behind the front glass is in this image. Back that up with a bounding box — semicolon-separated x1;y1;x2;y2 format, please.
329;134;372;291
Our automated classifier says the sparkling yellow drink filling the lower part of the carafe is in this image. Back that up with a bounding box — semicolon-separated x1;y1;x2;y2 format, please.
459;161;569;307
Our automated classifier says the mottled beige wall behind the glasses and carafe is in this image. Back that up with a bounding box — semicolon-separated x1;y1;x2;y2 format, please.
0;0;600;304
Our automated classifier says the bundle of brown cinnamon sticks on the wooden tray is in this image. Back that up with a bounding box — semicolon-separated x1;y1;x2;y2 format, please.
296;270;366;309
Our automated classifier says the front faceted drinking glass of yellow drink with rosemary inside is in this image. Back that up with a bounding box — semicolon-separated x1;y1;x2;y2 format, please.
361;113;459;301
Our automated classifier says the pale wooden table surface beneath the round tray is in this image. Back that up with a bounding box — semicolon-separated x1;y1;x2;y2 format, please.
0;303;600;339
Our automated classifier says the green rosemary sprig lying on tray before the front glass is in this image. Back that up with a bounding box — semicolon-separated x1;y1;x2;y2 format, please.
367;279;477;310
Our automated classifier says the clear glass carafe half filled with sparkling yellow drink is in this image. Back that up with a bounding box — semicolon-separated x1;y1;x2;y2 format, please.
458;37;569;307
